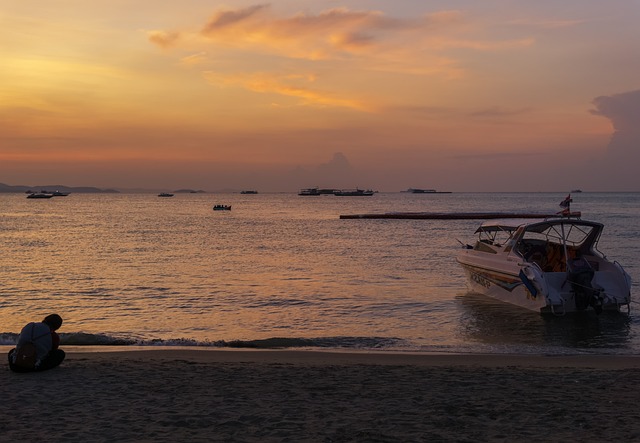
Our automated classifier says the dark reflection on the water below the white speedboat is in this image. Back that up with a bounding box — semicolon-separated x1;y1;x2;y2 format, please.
457;293;632;353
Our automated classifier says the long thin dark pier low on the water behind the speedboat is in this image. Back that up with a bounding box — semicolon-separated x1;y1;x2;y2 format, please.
340;212;580;220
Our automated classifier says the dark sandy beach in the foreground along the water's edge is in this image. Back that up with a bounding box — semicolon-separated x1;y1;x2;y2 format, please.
0;348;640;442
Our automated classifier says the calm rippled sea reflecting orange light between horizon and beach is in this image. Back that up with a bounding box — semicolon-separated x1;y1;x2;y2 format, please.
0;192;640;354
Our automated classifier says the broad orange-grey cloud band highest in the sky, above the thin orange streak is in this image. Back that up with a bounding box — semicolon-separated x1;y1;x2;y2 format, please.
148;4;532;60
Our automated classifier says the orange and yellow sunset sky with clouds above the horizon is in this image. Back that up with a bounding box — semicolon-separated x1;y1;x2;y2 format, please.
0;0;640;192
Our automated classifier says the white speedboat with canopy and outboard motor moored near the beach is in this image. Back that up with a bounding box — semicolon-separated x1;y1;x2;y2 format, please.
457;216;631;315
